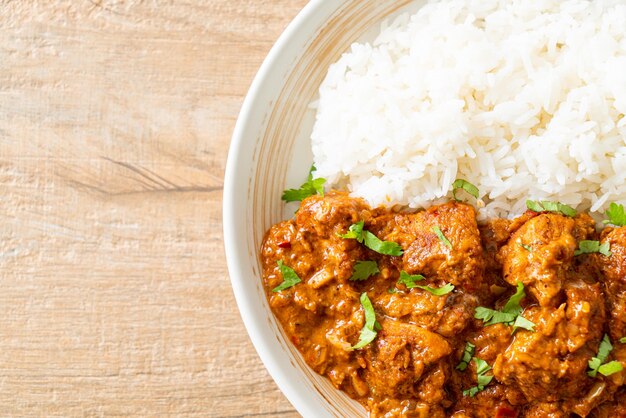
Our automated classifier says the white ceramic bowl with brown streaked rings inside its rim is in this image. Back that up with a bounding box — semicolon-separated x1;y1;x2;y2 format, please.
224;0;423;418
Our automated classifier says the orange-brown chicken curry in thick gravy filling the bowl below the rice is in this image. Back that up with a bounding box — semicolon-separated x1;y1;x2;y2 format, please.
261;192;626;418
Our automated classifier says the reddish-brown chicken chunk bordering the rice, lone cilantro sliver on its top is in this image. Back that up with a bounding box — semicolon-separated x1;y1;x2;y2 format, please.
372;202;484;292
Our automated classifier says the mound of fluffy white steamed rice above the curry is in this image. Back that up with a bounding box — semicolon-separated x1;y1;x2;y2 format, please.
311;0;626;217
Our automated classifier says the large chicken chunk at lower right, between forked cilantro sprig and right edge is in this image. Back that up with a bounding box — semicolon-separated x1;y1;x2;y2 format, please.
493;280;605;403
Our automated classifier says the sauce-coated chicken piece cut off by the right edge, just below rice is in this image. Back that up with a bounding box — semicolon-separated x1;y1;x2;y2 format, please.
593;227;626;341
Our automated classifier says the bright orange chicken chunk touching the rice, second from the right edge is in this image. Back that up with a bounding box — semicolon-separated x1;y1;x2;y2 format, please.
499;213;595;307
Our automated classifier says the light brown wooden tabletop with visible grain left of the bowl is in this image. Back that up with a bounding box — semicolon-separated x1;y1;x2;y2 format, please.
0;0;306;417
